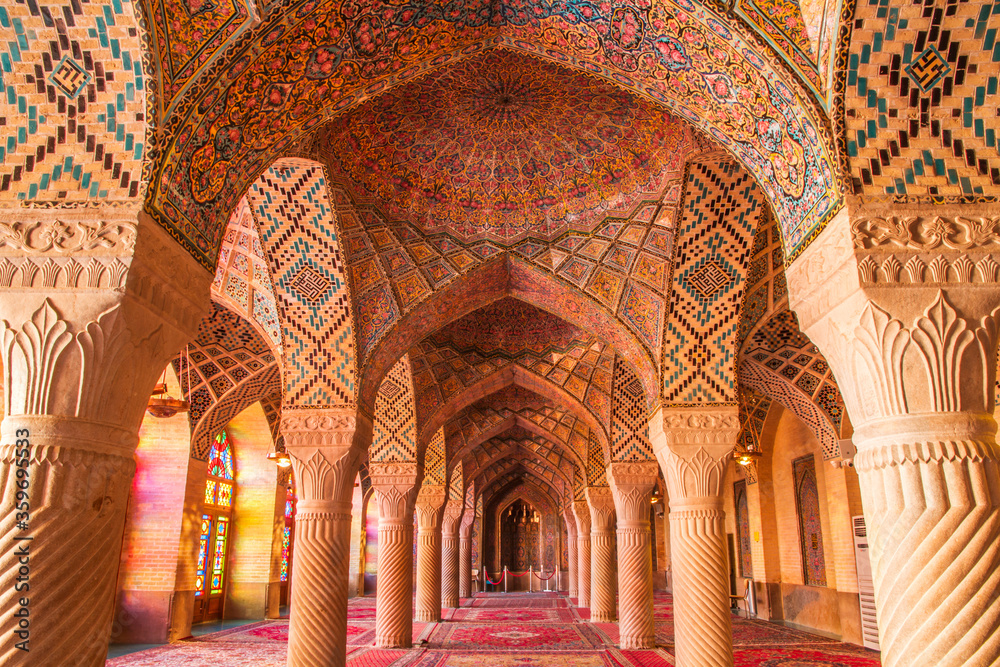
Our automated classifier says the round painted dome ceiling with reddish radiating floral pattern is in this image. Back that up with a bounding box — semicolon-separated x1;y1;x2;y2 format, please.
315;50;694;243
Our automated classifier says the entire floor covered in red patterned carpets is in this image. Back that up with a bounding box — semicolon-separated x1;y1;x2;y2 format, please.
107;593;881;667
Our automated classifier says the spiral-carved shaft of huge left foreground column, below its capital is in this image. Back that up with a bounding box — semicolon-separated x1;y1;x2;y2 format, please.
0;416;135;665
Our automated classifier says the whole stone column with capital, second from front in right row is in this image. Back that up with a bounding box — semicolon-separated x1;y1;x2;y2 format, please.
647;406;740;667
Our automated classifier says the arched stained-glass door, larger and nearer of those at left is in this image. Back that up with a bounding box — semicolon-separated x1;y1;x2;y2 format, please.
191;430;234;623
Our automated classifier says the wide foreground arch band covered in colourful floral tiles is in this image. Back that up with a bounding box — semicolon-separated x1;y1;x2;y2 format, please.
146;0;839;263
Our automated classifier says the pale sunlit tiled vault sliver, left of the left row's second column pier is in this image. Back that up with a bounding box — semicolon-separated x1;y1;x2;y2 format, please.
212;197;281;353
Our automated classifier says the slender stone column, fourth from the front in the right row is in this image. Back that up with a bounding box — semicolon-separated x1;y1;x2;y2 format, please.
587;486;618;623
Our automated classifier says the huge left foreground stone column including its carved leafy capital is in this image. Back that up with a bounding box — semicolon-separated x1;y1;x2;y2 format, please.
0;205;212;666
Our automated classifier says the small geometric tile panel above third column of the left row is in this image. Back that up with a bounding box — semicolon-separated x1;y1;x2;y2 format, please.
368;356;417;463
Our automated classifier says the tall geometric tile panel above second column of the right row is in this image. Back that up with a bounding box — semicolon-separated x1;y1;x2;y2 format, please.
662;159;766;404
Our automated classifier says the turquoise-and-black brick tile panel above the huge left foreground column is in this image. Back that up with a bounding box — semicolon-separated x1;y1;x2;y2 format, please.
0;0;146;201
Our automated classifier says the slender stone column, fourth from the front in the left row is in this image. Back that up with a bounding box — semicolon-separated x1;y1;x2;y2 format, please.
416;485;448;623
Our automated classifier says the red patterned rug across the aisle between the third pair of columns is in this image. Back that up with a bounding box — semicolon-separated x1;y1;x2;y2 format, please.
427;623;604;651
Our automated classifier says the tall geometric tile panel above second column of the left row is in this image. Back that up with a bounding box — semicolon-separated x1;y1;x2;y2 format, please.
247;159;355;405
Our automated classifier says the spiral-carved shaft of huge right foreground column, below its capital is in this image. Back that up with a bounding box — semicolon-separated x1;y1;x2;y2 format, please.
854;414;1000;667
